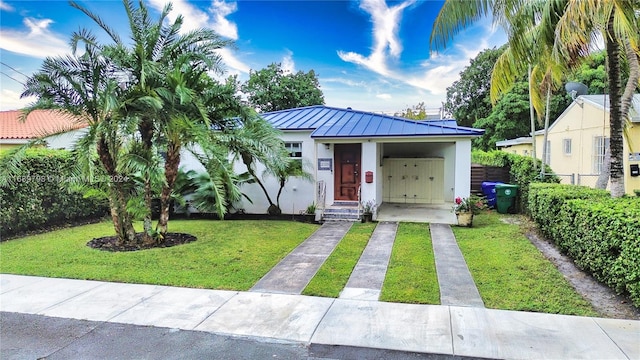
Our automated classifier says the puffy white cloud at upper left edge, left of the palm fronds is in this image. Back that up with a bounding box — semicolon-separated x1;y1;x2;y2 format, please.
0;18;70;58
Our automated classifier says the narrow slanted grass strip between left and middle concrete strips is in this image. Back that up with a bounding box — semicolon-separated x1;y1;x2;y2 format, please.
302;223;376;298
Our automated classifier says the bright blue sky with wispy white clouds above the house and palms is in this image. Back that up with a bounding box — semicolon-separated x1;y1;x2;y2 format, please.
0;0;506;113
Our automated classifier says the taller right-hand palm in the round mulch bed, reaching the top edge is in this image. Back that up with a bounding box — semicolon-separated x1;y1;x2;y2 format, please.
72;1;228;243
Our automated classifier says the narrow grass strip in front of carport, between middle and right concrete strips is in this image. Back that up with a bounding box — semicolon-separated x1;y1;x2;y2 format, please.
380;223;440;304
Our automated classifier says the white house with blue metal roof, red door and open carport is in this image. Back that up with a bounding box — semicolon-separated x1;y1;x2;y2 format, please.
224;106;484;214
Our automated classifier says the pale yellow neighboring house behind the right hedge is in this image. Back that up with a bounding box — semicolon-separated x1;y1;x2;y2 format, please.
496;94;640;194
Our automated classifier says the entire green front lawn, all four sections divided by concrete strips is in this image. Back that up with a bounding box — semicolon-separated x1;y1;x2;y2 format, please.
0;212;597;316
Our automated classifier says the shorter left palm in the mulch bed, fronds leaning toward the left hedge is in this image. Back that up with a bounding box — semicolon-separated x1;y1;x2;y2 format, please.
22;39;136;245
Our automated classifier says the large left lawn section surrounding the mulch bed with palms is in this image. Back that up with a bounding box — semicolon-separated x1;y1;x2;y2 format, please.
0;220;318;291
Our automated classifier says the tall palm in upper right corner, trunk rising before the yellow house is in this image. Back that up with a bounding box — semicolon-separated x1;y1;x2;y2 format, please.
431;0;640;197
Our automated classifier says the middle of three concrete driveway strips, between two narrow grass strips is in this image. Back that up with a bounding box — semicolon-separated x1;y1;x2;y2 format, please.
340;222;398;301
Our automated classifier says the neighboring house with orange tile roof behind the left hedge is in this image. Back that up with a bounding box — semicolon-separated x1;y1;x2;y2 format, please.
0;110;86;150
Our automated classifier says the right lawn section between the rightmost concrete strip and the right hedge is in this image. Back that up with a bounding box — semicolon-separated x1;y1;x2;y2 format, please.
452;212;597;316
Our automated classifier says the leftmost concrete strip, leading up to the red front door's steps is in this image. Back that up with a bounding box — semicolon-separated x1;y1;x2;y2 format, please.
251;221;351;294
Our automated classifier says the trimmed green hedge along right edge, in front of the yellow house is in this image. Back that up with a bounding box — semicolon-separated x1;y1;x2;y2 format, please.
529;184;640;306
